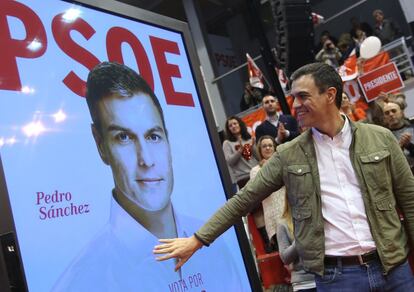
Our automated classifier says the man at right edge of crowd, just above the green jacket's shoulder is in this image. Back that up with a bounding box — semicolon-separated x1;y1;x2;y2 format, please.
384;101;414;173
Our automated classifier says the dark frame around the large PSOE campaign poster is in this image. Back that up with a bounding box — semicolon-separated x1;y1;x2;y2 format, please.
0;0;262;291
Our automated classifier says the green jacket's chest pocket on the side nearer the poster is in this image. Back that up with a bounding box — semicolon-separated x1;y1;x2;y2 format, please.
287;164;313;207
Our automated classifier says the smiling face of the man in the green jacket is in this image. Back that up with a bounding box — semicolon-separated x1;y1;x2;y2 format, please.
291;75;336;128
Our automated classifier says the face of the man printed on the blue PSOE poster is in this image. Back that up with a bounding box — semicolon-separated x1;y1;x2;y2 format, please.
93;93;174;211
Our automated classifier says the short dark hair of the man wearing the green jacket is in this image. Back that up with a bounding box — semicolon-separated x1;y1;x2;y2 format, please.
290;63;342;109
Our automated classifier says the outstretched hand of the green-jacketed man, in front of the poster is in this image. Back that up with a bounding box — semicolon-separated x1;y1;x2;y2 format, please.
153;235;203;271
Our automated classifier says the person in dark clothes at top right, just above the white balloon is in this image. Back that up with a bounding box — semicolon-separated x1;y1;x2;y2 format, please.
372;9;402;45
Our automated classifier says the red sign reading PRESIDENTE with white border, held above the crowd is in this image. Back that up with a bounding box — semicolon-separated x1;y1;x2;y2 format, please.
358;62;404;102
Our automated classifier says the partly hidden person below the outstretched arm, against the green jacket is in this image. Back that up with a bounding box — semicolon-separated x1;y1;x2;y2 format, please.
277;195;316;292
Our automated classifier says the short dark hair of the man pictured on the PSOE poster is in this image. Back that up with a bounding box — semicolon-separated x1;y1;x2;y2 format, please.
86;62;167;133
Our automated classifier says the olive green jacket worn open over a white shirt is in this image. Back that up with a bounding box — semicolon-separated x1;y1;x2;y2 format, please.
195;122;414;275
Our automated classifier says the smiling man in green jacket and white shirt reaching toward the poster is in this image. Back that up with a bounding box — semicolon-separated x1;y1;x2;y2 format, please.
154;63;414;291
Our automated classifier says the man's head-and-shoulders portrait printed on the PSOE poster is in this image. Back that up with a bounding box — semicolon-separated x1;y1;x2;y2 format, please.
53;62;243;292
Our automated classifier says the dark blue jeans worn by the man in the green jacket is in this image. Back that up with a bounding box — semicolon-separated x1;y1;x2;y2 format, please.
315;261;414;292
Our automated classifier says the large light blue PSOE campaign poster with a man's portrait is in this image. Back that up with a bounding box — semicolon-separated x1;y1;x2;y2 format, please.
0;0;251;292
